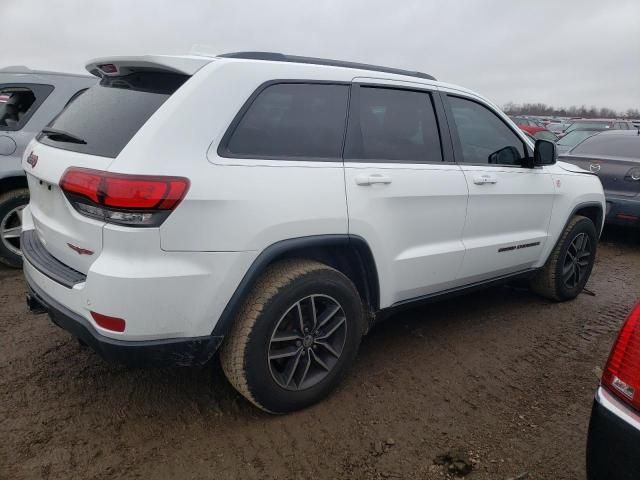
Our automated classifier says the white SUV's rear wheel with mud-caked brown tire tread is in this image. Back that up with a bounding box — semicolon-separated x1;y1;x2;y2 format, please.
220;260;364;413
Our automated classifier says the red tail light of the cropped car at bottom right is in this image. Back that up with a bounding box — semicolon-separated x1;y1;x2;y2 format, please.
602;303;640;410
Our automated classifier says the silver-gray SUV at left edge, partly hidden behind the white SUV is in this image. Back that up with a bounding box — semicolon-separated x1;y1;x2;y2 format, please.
0;67;97;267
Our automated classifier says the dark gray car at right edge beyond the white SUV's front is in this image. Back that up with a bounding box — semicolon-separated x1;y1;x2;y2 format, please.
558;130;640;227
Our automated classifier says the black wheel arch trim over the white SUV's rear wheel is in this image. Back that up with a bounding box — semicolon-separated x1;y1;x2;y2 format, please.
212;234;380;337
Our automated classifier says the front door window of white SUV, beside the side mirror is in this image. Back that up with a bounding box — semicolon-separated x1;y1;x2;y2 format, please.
449;96;526;166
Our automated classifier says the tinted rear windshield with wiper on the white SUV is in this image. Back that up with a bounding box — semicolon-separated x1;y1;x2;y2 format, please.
38;72;189;158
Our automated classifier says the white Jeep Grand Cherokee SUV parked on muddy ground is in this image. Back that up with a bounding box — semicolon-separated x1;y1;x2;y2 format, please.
22;52;605;413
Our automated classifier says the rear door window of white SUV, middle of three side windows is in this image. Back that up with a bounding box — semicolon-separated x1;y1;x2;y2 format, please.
345;87;442;162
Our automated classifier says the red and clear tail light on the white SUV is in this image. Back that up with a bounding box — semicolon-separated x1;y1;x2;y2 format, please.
60;168;189;227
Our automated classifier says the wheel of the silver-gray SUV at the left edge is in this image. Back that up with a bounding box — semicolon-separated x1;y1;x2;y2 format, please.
0;188;29;268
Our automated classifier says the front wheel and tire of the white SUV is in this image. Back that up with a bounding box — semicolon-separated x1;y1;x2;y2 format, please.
530;215;598;302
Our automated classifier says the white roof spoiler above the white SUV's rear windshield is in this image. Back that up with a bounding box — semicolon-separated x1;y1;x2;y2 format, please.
86;55;213;77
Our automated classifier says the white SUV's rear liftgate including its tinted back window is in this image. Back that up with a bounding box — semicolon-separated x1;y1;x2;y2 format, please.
23;65;195;274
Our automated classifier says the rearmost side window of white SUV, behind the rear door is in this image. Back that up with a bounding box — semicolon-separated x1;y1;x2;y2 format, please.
221;83;349;159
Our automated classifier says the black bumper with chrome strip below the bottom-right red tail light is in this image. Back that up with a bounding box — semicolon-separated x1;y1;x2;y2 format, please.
587;387;640;480
